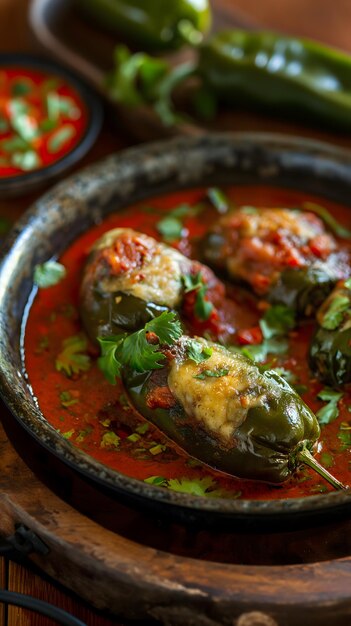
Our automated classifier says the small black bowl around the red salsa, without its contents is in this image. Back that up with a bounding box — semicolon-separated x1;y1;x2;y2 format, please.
0;53;103;197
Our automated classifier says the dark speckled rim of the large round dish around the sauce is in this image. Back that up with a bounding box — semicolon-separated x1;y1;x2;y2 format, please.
0;133;351;523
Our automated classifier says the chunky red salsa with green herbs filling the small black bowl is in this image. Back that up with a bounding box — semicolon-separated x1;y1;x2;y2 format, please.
0;67;88;177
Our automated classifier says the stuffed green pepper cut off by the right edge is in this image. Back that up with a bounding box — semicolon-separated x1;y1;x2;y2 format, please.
309;278;351;387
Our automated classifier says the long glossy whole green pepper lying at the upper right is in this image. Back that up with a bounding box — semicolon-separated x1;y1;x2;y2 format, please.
198;30;351;130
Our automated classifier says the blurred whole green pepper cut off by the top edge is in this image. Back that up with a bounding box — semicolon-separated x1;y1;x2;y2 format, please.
75;0;211;50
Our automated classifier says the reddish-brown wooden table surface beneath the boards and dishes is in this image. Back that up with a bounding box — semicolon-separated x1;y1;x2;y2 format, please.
0;0;351;626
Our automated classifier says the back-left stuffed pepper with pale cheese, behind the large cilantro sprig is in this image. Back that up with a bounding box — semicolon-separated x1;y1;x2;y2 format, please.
80;228;224;341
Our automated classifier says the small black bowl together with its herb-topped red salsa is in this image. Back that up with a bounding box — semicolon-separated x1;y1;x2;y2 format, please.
0;55;102;195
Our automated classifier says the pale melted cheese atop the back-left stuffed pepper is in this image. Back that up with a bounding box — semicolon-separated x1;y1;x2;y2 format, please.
93;228;191;308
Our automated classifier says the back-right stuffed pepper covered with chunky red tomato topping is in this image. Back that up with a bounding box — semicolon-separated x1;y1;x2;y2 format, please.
202;206;349;317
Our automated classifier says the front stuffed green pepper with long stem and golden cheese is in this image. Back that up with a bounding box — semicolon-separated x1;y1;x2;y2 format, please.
122;336;342;488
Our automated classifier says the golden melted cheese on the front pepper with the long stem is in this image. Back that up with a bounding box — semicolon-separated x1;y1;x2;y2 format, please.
168;341;269;444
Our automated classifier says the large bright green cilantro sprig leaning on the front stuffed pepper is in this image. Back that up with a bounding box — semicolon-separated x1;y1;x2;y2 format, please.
98;311;182;385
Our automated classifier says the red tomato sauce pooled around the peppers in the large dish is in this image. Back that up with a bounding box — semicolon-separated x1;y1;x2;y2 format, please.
24;187;351;499
